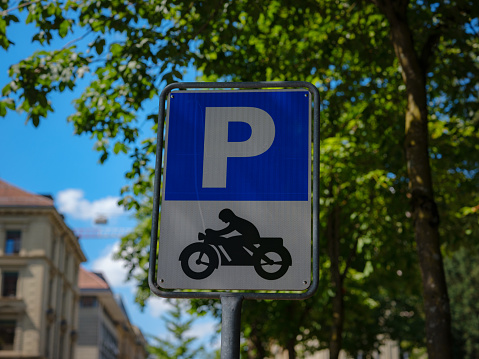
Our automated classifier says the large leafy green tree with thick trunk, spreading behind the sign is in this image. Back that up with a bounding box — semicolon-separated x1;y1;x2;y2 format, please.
0;0;479;358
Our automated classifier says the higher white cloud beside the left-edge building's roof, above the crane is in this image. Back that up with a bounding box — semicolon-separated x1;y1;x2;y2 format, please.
56;188;125;220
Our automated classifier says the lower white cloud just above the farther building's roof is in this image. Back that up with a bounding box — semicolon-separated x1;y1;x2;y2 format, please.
91;243;135;290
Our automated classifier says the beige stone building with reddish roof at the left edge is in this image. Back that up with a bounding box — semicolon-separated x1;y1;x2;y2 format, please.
0;179;86;359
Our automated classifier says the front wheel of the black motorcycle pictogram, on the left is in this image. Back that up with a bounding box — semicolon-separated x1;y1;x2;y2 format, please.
180;243;218;279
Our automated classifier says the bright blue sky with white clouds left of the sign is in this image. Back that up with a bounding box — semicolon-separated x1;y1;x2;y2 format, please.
0;11;217;354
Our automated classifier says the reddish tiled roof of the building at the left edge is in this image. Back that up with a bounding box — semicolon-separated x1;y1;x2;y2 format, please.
0;179;53;207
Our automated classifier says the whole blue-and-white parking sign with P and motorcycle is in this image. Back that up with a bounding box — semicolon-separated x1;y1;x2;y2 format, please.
157;90;311;290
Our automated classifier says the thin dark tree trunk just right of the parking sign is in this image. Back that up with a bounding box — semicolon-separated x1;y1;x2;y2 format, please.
326;206;344;359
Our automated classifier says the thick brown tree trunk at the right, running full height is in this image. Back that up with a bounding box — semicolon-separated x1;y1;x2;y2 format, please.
376;0;452;359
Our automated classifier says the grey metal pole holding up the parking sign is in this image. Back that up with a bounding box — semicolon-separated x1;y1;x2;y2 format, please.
221;294;243;359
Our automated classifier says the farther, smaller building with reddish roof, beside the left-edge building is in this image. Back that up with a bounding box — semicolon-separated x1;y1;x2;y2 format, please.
76;268;147;359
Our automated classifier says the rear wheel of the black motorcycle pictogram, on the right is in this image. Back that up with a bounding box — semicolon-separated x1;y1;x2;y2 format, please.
253;247;291;280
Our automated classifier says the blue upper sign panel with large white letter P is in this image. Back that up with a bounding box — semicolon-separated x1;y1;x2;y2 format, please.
164;90;311;201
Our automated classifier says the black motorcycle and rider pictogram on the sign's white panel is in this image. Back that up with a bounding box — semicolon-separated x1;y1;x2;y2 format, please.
179;209;292;280
